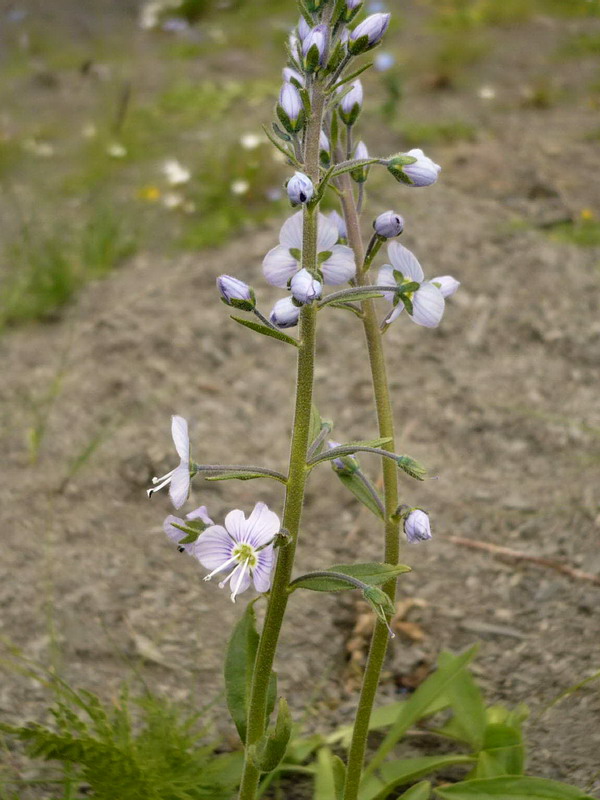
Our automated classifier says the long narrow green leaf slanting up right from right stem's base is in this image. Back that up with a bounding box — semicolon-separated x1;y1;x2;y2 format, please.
365;646;477;774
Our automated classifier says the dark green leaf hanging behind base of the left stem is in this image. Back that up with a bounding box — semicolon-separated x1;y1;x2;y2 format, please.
225;603;277;743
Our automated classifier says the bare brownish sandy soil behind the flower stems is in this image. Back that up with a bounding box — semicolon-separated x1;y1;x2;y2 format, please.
0;3;600;792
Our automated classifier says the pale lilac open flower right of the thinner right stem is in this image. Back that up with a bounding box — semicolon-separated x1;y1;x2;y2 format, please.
377;242;445;328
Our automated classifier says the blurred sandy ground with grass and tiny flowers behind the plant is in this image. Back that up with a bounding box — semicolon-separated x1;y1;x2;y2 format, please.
0;0;600;791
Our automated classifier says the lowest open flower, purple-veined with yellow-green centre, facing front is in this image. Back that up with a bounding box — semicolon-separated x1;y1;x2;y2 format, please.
194;503;280;603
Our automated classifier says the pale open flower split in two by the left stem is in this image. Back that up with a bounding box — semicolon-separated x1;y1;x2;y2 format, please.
263;211;356;288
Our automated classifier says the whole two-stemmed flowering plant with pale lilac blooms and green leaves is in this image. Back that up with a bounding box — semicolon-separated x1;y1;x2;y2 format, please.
148;0;596;800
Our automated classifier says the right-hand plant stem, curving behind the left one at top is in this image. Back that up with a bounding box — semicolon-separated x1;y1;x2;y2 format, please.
340;174;400;800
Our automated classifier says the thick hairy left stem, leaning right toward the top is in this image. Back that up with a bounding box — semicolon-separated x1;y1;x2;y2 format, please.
239;82;325;800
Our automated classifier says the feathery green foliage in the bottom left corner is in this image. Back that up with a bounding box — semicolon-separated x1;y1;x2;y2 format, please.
2;684;241;800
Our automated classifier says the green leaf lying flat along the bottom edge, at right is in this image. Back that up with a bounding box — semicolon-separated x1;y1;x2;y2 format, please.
435;775;593;800
